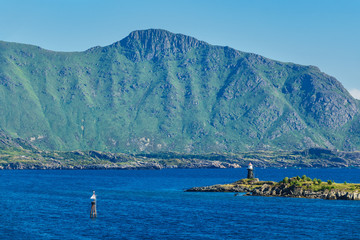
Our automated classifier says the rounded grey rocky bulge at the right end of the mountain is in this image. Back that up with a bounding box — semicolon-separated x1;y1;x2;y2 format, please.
283;70;358;129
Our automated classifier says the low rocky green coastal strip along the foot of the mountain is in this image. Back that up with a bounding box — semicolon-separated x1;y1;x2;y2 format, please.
0;147;360;169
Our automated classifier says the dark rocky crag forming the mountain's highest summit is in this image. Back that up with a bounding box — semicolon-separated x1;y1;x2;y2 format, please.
115;29;206;62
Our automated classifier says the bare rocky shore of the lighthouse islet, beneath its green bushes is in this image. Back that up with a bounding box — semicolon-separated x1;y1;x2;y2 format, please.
185;179;360;200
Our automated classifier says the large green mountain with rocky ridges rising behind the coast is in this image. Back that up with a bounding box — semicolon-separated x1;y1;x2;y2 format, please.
0;29;360;153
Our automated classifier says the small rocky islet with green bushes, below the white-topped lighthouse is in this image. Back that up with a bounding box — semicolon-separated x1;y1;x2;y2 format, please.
186;175;360;200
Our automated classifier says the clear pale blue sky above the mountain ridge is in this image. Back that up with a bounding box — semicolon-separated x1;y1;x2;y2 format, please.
0;0;360;98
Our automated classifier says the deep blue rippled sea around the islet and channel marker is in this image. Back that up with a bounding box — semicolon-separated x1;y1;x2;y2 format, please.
0;169;360;239
